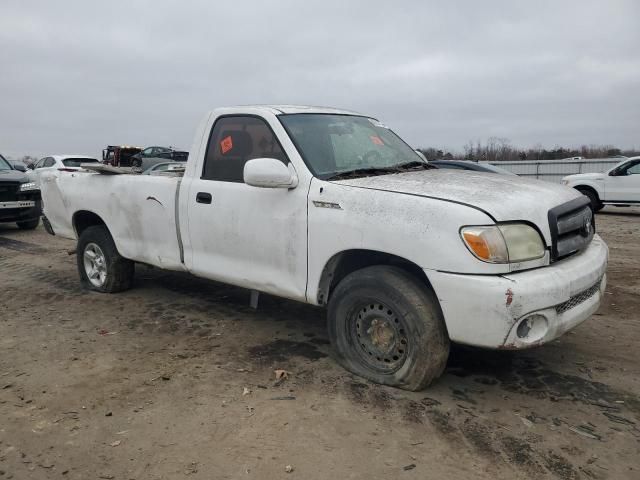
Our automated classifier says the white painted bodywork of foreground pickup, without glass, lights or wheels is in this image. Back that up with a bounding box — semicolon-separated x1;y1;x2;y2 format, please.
43;106;607;348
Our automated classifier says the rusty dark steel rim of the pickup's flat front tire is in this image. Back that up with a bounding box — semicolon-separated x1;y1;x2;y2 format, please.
349;302;409;373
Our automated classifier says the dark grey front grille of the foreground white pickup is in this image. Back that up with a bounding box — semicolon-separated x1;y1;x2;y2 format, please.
548;196;596;261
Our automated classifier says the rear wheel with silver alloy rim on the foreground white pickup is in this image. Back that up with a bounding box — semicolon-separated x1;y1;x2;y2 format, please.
76;225;135;293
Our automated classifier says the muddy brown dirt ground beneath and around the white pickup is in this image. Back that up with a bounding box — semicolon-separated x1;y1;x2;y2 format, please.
0;207;640;480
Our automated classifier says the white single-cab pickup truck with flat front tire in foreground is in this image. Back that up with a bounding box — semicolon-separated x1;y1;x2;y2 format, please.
43;106;608;390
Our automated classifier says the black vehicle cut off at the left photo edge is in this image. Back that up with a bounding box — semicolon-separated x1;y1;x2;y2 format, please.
0;155;42;230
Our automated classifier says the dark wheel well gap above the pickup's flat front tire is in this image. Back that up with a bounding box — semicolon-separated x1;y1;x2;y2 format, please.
316;249;432;305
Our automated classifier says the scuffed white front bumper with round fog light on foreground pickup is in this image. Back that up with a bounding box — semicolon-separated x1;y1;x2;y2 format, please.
425;235;609;349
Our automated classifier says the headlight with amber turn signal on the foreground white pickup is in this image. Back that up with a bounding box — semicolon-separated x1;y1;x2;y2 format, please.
460;223;545;263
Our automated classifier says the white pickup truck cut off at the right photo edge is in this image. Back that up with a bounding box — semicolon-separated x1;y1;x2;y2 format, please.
562;157;640;211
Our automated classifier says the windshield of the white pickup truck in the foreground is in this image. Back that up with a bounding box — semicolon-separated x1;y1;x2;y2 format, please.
278;113;425;178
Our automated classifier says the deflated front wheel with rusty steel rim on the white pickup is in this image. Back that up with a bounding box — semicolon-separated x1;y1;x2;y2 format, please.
328;266;449;391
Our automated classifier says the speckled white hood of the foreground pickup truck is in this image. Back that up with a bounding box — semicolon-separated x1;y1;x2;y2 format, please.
332;169;581;244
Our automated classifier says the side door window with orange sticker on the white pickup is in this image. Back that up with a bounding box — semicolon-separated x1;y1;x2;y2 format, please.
202;116;289;183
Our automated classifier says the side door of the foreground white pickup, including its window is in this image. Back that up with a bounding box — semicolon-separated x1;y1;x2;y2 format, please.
185;115;308;301
